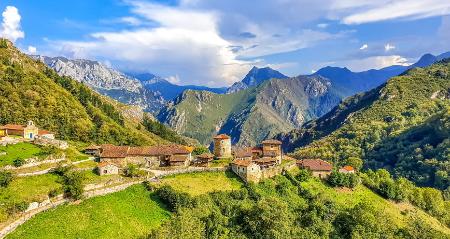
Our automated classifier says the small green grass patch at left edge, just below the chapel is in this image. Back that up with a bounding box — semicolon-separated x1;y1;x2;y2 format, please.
0;143;42;166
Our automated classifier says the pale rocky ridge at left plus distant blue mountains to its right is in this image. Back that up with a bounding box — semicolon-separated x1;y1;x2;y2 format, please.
36;56;226;112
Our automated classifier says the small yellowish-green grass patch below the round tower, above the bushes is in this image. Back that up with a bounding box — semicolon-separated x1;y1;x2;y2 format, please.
160;172;242;196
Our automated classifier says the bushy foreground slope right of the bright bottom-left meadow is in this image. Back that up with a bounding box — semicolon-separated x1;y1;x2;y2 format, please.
149;172;450;239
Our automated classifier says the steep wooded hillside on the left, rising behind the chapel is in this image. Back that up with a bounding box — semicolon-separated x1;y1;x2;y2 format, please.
0;40;164;144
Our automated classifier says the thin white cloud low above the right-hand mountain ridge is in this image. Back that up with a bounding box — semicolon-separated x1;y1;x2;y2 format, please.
336;55;412;72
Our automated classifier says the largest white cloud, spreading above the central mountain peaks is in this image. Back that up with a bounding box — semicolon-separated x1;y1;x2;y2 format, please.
51;2;250;86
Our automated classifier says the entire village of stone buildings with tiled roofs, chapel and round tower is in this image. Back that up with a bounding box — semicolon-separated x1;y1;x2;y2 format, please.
0;121;355;182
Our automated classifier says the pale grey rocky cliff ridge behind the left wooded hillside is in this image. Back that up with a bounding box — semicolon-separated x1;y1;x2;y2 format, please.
35;56;165;112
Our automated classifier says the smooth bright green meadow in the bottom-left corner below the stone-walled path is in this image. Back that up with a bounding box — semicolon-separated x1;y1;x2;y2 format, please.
7;185;170;239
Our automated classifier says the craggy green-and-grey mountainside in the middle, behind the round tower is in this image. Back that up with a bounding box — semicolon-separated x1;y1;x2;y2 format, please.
157;77;340;145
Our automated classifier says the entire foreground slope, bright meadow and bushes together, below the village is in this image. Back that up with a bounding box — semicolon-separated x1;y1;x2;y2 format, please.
7;173;450;238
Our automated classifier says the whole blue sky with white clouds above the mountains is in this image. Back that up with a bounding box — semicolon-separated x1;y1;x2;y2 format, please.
0;0;450;86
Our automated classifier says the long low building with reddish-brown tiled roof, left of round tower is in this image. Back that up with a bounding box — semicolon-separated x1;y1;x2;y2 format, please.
99;145;191;167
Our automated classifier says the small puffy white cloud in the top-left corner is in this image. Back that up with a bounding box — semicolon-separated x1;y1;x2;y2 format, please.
0;6;25;42
